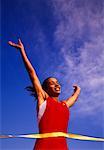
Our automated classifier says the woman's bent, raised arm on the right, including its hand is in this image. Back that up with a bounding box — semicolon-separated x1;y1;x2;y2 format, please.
64;84;81;107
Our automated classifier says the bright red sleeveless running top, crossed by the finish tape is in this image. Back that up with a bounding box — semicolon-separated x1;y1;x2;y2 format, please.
34;97;69;150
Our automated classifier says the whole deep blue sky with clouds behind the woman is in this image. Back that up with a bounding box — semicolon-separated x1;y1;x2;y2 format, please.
0;0;104;150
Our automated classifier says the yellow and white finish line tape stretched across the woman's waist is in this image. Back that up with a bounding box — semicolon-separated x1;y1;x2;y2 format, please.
0;132;104;142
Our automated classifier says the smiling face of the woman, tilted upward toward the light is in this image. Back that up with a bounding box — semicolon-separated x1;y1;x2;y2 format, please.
47;78;61;97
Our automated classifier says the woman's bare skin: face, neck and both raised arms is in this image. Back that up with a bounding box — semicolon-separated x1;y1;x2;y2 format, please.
8;39;80;107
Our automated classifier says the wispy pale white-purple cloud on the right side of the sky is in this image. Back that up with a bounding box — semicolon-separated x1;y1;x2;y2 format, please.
50;0;104;114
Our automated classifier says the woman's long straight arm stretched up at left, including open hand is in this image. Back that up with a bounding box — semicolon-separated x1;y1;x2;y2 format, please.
8;39;48;105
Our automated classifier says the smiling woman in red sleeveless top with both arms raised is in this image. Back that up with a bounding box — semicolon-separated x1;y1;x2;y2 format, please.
9;39;80;150
